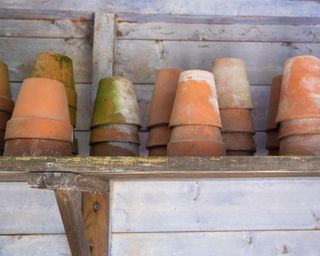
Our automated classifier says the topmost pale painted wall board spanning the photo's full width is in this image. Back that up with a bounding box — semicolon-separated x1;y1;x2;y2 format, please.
0;0;319;17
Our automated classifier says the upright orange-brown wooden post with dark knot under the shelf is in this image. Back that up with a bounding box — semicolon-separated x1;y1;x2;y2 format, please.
82;192;109;256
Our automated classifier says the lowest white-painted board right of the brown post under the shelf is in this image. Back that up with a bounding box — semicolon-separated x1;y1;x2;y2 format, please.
111;231;320;256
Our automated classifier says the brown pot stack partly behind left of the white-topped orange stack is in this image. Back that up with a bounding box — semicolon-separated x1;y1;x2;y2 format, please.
147;68;182;156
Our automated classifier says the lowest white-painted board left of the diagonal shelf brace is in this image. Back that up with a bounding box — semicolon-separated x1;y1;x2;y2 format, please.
0;235;71;256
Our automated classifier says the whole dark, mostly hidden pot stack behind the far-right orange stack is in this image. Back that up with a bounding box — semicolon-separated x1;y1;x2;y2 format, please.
266;75;282;156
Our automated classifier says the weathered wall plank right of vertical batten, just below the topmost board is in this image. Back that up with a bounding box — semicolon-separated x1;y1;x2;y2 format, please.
117;15;320;43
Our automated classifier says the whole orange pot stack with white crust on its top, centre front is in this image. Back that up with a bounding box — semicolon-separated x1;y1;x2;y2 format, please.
167;70;225;156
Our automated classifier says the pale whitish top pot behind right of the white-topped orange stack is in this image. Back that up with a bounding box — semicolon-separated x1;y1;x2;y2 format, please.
212;58;253;109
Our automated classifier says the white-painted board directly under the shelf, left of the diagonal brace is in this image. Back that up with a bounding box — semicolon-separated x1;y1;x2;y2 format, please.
0;182;64;234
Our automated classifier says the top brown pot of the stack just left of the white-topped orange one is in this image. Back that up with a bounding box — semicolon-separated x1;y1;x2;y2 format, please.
148;68;182;128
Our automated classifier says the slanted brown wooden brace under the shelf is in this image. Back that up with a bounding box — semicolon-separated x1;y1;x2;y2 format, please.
54;190;91;256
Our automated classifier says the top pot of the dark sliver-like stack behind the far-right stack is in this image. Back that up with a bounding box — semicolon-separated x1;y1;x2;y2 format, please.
267;75;282;130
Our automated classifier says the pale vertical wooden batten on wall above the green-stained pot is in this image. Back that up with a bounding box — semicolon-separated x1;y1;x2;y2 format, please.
91;12;115;102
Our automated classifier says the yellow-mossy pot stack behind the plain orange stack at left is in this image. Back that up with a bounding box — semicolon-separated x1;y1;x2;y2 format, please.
31;52;78;155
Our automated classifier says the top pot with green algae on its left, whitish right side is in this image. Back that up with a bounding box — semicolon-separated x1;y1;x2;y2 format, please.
91;77;140;127
